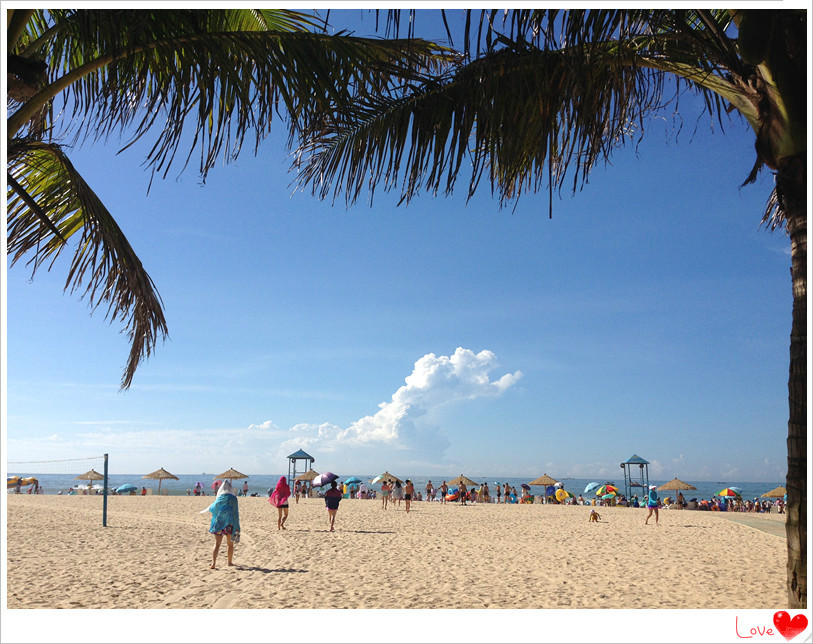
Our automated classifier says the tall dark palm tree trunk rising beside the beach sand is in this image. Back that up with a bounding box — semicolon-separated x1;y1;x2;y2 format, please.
776;157;807;608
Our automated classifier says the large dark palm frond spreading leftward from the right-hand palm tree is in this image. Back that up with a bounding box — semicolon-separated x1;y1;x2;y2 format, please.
295;10;758;211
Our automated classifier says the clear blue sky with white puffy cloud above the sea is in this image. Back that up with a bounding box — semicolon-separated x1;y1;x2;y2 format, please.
4;8;791;481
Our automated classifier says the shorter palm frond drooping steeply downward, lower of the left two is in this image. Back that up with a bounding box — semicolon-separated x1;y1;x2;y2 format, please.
7;139;167;389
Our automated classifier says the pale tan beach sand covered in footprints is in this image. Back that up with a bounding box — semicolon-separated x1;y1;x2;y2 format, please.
7;495;787;609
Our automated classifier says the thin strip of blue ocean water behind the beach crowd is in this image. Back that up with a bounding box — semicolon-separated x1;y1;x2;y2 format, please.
8;472;785;501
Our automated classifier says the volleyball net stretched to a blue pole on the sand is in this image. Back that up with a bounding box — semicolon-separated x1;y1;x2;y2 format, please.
6;454;108;527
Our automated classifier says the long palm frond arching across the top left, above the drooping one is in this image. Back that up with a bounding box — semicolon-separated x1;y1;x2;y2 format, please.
9;10;450;184
